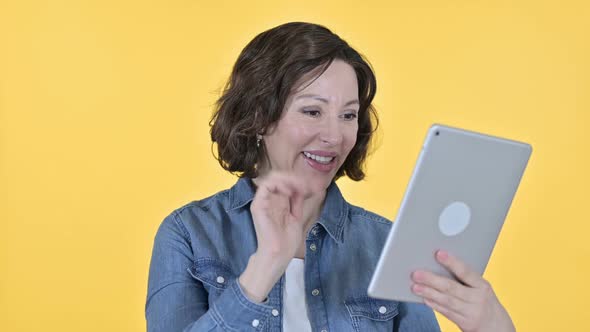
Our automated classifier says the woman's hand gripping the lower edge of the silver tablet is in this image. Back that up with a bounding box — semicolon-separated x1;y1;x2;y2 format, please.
412;250;515;332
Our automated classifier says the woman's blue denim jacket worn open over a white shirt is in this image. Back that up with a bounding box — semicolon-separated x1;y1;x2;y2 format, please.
145;178;439;332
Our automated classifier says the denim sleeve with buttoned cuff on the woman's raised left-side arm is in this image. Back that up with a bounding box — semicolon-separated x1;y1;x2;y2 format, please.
145;212;272;332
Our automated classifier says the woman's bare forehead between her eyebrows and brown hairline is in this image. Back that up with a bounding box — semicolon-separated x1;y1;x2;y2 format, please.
292;59;358;100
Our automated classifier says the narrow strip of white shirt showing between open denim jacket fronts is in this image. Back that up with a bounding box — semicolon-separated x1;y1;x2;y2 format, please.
283;258;311;332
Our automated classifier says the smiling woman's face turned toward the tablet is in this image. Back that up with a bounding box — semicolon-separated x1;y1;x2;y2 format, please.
263;60;359;191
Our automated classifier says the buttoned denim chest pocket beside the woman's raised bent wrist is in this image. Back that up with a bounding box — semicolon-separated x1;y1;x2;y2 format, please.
187;258;236;303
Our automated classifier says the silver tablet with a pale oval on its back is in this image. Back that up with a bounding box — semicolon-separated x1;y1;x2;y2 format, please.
368;125;532;302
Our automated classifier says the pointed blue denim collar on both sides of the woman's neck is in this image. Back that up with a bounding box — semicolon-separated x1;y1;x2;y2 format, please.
229;178;349;243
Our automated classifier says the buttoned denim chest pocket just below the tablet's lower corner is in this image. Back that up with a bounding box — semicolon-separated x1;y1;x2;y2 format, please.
344;295;398;331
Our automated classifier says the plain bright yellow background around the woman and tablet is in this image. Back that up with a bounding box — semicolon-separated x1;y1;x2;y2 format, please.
0;0;590;331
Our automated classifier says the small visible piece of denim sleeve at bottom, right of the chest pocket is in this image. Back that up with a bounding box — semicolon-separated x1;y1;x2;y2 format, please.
393;302;440;332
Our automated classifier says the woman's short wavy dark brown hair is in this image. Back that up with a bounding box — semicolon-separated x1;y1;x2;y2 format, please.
210;22;378;181
